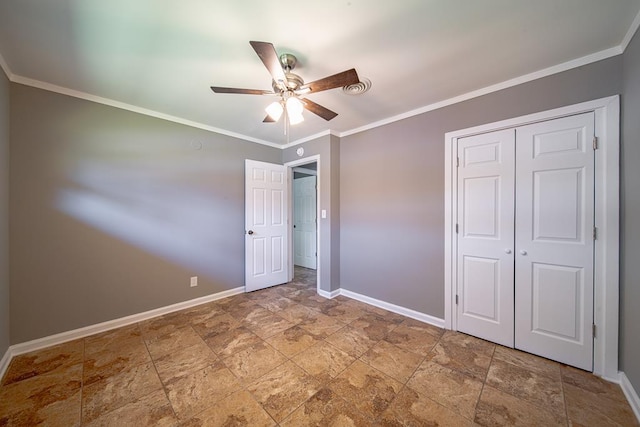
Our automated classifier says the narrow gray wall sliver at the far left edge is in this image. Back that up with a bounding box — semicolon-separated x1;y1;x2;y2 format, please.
0;69;11;359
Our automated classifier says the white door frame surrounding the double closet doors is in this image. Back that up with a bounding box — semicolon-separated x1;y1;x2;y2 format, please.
444;95;620;382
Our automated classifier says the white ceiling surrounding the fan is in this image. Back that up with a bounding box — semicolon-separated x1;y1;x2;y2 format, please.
0;0;640;145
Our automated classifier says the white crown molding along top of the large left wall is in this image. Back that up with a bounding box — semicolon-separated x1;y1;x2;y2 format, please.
11;76;282;148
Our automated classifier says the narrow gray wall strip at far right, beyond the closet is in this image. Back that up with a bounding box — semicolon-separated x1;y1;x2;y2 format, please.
620;33;640;392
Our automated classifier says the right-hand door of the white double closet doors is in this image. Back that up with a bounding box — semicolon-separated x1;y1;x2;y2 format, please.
515;113;595;371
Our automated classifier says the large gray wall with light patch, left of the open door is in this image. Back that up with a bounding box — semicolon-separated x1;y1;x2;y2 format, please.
10;84;281;343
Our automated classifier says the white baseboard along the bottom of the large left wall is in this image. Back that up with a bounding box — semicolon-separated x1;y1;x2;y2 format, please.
9;286;244;358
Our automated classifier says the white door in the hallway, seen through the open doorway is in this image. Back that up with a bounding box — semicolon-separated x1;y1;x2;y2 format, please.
293;176;317;270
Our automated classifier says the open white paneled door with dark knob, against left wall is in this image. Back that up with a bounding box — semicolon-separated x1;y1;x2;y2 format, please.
245;160;288;292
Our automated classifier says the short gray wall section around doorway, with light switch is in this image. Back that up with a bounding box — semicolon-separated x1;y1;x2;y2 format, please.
282;135;340;292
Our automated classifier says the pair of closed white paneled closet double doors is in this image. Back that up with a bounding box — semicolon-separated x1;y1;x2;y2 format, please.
456;113;595;371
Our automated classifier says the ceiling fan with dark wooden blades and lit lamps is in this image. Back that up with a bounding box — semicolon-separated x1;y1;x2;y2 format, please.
211;41;360;126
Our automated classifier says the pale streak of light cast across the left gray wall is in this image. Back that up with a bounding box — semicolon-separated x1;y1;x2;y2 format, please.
56;155;242;279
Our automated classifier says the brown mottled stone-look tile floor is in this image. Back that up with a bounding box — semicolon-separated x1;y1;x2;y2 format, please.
0;269;639;427
